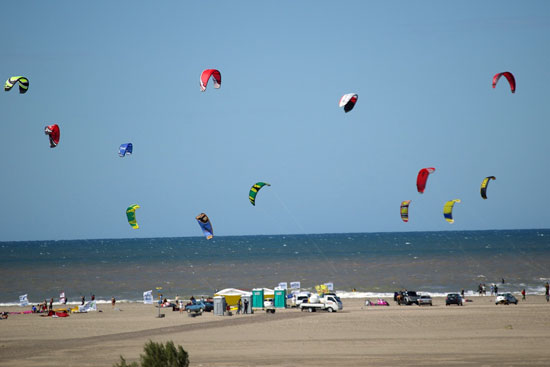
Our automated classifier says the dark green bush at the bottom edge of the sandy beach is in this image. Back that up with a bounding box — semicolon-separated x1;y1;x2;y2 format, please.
113;340;189;367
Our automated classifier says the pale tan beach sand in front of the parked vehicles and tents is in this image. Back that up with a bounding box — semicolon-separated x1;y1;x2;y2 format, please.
0;296;550;367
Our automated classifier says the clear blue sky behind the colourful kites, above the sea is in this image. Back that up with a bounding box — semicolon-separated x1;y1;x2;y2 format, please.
0;1;550;241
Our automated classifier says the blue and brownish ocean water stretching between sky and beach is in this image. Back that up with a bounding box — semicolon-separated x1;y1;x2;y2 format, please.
0;229;550;305
